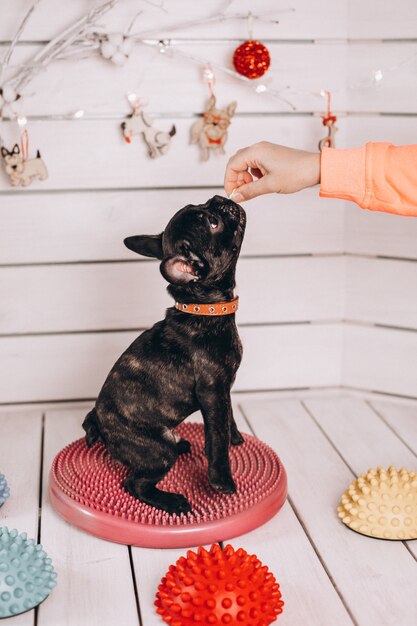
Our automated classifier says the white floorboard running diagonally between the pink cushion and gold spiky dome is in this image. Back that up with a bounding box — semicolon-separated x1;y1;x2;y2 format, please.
242;399;417;626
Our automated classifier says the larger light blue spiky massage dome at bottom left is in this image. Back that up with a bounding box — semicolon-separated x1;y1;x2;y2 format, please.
0;527;56;618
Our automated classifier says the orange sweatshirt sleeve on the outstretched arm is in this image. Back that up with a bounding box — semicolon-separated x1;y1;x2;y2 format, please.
320;143;417;216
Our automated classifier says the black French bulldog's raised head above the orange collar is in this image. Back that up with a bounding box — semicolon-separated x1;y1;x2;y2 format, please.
125;196;246;297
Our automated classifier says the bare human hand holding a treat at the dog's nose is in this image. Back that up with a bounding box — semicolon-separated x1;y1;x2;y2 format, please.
224;141;320;202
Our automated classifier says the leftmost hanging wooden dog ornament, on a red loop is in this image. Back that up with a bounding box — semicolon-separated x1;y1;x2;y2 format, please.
1;130;48;187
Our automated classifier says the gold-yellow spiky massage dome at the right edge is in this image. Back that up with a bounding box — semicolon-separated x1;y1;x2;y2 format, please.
337;465;417;540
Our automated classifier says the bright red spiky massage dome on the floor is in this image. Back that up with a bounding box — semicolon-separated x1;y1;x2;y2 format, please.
155;544;284;626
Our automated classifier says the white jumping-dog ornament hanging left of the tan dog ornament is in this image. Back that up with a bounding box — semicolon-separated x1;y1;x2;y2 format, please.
121;97;177;159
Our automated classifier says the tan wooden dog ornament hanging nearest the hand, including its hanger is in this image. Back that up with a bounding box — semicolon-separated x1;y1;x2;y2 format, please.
191;68;237;161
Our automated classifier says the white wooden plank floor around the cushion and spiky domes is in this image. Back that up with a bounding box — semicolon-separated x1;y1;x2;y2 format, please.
0;392;417;626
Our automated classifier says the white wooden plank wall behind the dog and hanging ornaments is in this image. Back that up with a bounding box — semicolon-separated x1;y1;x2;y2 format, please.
0;0;417;403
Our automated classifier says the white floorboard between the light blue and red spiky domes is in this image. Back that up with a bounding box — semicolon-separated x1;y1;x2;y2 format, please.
38;409;139;626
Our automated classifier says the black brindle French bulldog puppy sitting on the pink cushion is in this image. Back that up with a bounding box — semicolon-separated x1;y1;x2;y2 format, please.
83;196;246;514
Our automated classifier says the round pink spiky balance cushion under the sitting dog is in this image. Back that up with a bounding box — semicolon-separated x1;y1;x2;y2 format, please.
49;423;287;548
